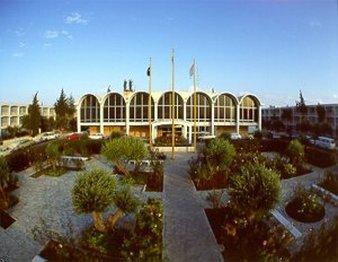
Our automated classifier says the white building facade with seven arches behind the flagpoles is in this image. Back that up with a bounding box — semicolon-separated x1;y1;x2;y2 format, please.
77;91;261;143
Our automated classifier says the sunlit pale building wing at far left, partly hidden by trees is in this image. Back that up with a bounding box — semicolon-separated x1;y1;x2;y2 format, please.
0;104;55;133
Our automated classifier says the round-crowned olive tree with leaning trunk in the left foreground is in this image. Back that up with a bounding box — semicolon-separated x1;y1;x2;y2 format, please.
72;169;116;232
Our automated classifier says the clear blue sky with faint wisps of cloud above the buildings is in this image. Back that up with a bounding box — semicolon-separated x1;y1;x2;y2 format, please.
0;0;338;106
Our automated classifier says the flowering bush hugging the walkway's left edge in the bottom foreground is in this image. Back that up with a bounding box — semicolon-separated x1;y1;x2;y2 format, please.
122;199;163;261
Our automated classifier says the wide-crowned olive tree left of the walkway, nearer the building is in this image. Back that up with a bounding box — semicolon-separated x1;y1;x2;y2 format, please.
103;137;149;176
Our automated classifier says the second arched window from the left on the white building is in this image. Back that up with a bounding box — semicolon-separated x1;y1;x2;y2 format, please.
103;93;126;122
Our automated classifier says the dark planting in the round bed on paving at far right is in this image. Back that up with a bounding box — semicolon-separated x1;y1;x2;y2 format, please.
285;186;325;223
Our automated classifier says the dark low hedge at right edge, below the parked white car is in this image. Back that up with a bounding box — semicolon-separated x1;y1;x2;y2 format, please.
305;146;336;168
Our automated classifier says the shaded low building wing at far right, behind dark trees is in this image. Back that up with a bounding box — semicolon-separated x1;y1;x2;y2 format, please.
262;104;338;137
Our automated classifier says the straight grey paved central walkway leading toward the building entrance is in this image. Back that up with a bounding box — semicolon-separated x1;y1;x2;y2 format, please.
163;153;223;262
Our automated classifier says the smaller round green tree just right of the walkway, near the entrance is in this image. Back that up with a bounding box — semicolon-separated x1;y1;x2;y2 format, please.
205;138;236;170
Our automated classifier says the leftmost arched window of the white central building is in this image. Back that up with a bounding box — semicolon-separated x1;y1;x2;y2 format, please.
80;95;100;123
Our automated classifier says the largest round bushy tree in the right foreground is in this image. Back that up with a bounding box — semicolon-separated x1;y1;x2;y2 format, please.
229;163;281;220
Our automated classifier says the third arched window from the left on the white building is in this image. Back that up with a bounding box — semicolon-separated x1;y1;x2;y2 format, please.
129;92;154;122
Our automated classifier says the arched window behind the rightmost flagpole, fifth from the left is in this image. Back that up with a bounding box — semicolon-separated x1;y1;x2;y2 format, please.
187;92;211;121
